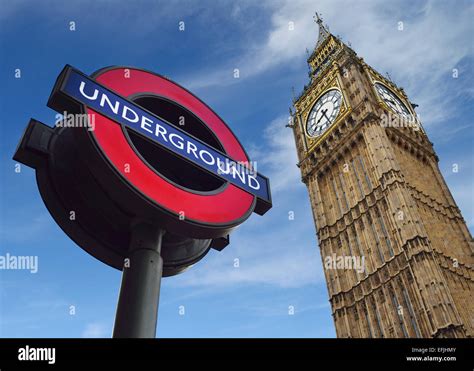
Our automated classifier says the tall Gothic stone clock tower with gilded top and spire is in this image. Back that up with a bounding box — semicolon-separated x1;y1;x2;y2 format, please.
290;15;474;338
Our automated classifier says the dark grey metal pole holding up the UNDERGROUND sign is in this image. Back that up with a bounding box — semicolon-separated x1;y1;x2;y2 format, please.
113;222;164;338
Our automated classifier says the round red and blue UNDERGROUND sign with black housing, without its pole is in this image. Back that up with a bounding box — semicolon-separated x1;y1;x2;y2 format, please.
14;66;271;275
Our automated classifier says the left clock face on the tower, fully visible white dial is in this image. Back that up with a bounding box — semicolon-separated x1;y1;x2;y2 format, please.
306;89;342;137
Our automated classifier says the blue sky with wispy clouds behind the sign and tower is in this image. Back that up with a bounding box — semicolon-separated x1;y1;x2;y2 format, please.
0;0;474;337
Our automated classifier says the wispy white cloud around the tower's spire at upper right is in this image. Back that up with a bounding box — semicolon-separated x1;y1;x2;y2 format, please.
184;0;474;126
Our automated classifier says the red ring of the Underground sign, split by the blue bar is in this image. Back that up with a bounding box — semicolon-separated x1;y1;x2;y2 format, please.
87;67;254;225
